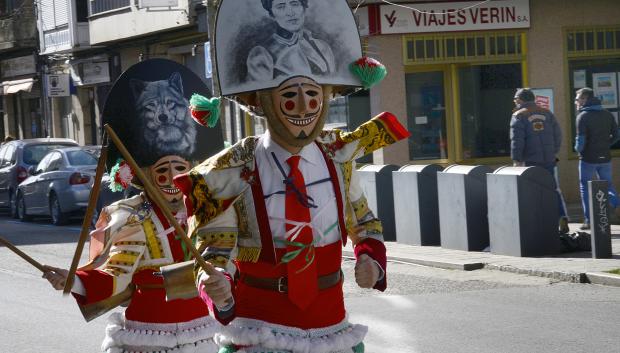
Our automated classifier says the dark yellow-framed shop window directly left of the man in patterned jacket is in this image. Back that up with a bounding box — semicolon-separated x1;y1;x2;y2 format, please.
459;64;522;159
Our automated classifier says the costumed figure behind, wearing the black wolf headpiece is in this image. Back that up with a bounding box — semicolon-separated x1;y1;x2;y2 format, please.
44;59;228;353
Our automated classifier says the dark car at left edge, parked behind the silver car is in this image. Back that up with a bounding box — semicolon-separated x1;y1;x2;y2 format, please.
0;138;78;217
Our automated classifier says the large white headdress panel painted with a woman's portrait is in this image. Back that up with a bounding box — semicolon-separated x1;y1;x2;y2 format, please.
213;0;378;96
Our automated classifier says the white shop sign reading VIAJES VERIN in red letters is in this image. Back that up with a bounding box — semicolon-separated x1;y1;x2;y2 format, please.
378;0;530;34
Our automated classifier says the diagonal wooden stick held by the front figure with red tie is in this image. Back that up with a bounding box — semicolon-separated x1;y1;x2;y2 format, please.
103;124;216;274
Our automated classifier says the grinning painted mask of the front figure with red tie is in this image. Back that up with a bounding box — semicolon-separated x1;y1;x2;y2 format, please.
271;76;323;139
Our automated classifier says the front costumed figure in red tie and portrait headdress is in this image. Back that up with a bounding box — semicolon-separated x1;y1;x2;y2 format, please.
162;0;409;353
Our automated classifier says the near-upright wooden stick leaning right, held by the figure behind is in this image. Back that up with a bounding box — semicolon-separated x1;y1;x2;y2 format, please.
62;136;108;295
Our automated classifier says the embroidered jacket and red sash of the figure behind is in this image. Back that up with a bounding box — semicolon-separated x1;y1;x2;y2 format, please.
74;195;209;323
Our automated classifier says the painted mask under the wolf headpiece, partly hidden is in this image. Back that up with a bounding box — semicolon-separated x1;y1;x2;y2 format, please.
149;156;190;202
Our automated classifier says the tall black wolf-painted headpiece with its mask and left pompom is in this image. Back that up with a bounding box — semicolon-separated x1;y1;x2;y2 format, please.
103;59;224;195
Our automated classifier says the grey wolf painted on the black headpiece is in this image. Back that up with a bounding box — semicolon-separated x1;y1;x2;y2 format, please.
129;72;196;155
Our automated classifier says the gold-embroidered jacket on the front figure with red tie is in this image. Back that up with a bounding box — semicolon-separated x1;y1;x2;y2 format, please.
175;113;409;320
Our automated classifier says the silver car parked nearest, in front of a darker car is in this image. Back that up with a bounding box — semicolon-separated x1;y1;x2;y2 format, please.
16;146;97;225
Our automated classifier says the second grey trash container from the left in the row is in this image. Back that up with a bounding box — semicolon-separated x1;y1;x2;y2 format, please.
392;164;443;245
